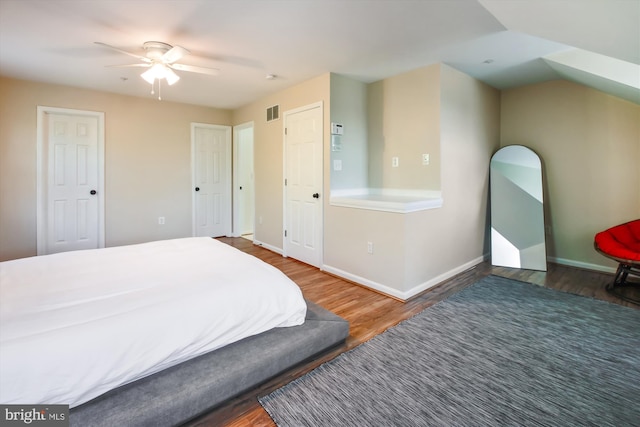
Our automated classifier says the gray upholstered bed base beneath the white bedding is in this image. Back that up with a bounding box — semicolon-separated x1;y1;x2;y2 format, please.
69;301;349;427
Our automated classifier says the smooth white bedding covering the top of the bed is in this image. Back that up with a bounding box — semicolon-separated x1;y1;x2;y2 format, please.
0;237;306;407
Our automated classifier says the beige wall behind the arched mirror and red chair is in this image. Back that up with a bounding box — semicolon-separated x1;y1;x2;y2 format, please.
501;80;640;268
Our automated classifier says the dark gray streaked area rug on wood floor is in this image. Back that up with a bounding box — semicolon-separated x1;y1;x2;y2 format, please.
260;276;640;427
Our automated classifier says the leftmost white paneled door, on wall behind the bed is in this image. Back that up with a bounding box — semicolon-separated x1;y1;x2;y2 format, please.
38;107;104;255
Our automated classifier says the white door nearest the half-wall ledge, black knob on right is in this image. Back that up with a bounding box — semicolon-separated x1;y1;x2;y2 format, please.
284;103;323;267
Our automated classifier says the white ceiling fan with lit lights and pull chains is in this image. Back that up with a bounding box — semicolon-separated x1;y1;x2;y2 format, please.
95;41;220;99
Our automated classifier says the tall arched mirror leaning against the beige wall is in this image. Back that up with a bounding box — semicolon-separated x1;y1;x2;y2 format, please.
490;145;547;271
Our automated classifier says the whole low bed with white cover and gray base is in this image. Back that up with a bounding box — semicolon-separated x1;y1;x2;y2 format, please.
0;238;348;425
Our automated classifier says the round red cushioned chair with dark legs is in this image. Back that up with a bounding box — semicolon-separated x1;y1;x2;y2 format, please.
593;219;640;304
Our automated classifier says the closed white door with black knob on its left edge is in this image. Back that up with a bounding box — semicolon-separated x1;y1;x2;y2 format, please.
191;123;231;237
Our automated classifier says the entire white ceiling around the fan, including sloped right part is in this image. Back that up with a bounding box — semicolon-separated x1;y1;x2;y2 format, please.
0;0;640;108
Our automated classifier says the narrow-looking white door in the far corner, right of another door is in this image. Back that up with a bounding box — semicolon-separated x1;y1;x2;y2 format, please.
233;122;255;237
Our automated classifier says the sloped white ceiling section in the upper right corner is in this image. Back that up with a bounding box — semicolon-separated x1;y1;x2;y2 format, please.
479;0;640;104
